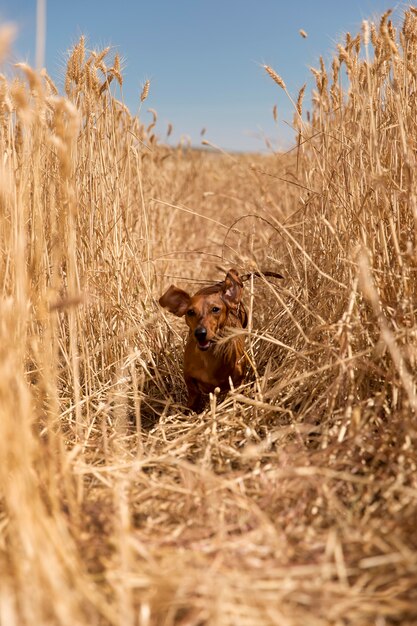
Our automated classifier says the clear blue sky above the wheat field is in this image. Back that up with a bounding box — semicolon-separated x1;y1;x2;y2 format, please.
0;0;396;151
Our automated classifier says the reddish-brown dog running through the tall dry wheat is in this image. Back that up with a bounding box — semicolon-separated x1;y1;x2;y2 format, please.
159;269;247;410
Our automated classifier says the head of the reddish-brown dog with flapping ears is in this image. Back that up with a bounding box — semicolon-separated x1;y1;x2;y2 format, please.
159;269;247;350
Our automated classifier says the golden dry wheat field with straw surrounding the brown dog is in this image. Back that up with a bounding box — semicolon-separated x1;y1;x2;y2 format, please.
0;9;417;626
